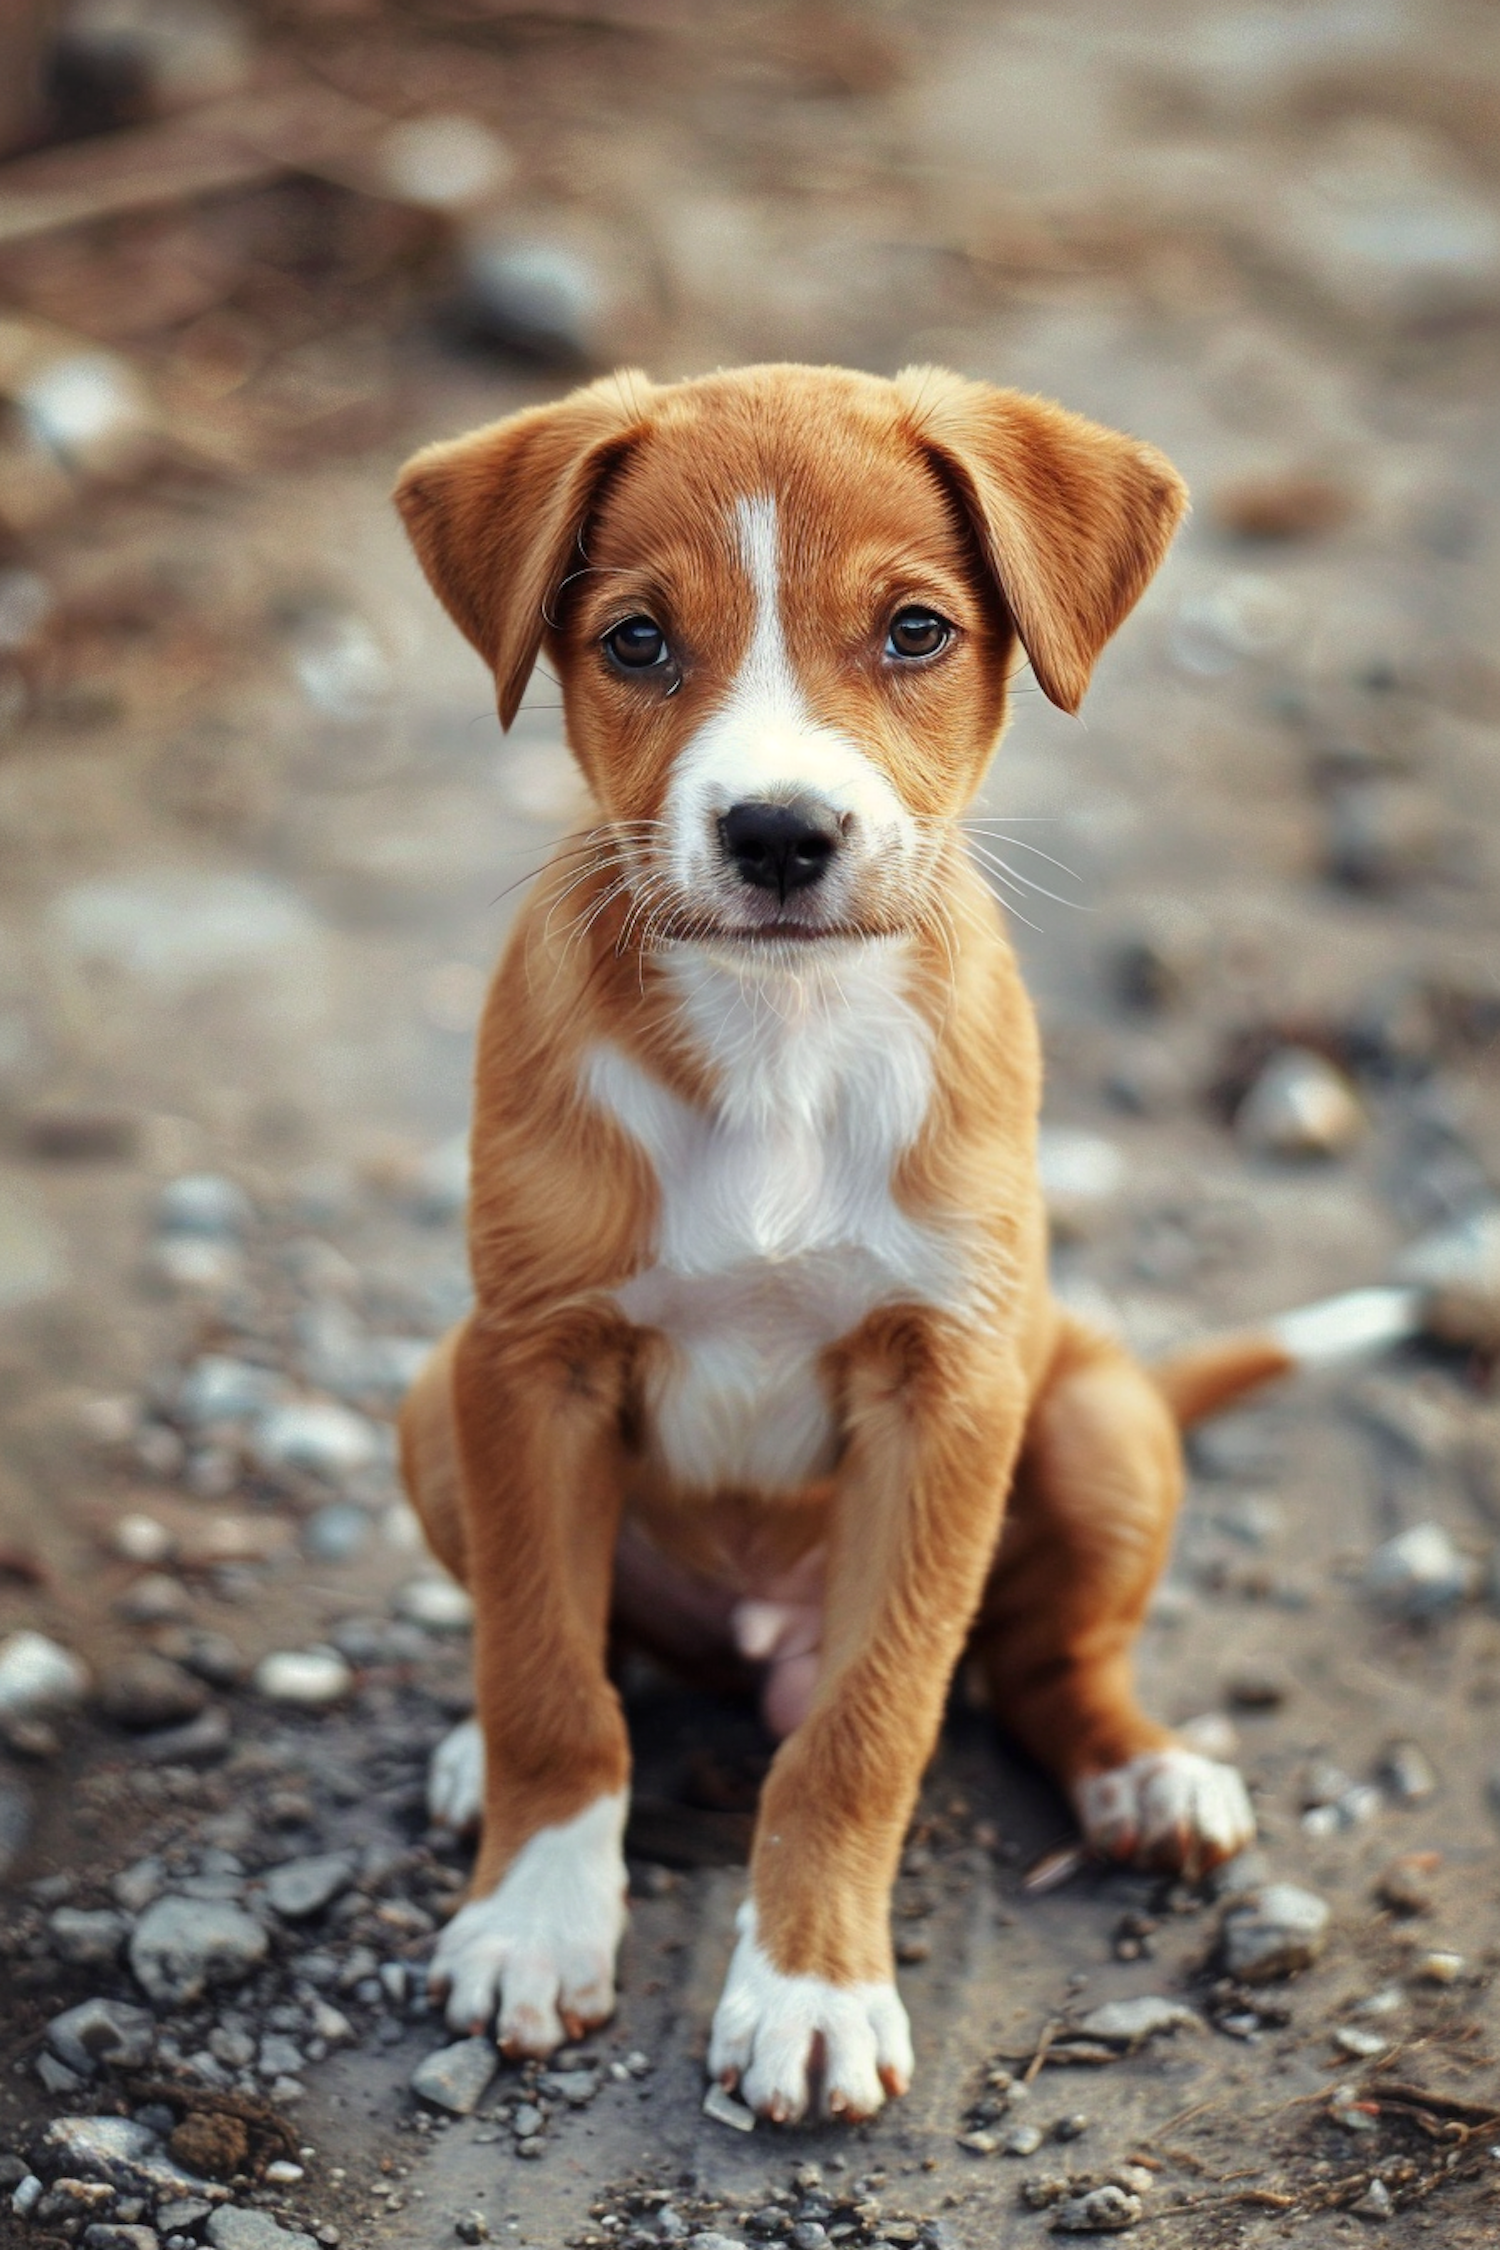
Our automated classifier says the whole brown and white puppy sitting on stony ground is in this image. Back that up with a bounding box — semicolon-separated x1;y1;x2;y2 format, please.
396;367;1421;2120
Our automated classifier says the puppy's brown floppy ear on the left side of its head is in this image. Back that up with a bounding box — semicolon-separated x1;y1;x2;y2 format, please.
394;371;652;727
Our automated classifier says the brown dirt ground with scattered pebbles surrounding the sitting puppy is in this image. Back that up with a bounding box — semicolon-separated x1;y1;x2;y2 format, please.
0;0;1500;2250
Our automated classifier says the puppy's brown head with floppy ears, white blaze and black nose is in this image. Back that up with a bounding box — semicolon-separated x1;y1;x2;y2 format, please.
396;367;1185;950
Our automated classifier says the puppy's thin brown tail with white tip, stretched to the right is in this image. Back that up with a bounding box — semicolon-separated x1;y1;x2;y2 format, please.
1149;1287;1421;1429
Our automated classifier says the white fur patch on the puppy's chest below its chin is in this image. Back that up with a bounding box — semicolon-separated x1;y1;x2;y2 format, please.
585;943;960;1490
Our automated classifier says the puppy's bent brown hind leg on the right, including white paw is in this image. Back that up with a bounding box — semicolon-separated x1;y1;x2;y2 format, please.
972;1323;1255;1874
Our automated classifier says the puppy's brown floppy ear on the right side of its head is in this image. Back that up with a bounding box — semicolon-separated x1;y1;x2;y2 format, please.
895;367;1187;711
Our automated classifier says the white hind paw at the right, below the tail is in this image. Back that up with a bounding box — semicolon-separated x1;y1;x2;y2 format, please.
1075;1748;1255;1877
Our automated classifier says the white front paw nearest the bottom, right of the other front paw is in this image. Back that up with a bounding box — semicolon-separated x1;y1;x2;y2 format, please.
708;1899;911;2124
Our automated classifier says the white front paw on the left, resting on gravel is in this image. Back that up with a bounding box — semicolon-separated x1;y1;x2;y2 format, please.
427;1789;625;2054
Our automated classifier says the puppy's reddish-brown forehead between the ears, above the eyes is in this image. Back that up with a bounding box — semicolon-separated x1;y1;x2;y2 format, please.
591;371;963;581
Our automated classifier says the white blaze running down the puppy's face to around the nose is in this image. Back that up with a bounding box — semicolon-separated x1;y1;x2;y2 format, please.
668;493;915;887
